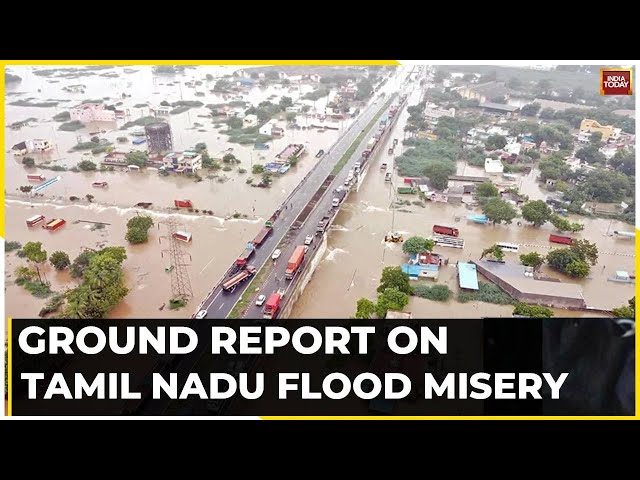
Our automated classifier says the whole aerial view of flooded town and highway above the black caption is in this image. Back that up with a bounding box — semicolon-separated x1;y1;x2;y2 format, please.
5;65;635;322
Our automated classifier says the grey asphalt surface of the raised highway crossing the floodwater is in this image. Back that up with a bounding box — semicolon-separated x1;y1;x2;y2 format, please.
200;72;410;318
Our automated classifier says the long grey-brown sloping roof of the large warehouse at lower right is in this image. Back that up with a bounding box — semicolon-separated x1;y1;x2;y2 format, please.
473;260;584;300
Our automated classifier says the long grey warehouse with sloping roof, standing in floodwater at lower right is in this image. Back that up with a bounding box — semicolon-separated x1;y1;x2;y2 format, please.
472;260;587;310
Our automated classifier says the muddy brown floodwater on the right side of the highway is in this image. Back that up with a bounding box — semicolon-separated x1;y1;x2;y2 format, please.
291;93;635;318
